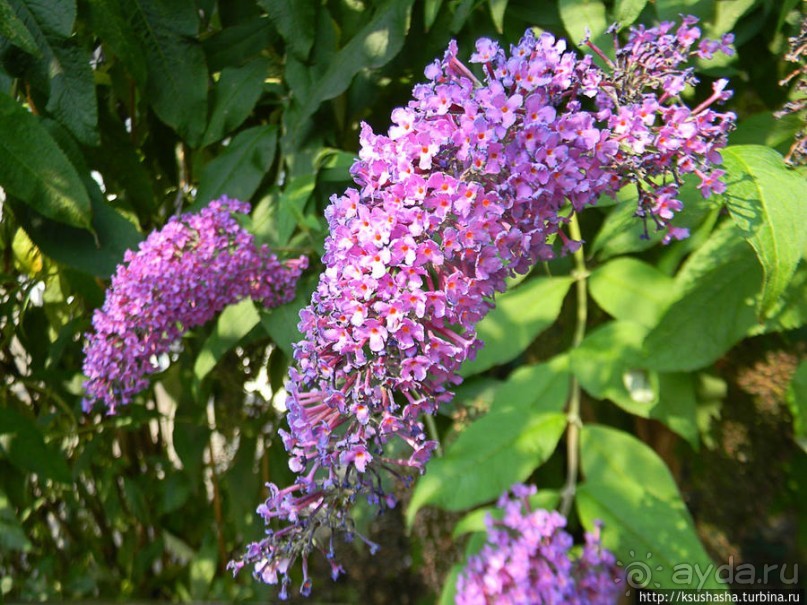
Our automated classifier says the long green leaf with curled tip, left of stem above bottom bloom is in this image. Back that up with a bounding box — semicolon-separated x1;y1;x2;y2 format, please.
406;360;569;526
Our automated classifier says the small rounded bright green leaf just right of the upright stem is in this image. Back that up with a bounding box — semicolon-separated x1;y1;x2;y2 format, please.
589;257;677;328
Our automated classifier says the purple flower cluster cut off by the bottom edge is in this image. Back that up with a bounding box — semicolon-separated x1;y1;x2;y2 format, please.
455;485;620;605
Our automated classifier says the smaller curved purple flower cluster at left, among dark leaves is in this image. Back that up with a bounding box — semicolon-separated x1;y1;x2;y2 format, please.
82;197;308;414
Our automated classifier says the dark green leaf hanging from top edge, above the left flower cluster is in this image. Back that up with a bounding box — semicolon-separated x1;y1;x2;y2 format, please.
123;0;207;147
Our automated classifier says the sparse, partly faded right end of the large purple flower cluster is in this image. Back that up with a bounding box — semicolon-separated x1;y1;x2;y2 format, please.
586;16;736;238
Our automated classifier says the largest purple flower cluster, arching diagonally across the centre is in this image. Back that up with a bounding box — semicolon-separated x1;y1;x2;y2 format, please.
231;19;733;595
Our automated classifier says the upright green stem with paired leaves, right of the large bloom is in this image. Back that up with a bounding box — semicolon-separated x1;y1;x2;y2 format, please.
560;214;588;517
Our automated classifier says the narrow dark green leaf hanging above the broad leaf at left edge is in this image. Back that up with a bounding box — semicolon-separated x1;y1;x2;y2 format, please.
10;0;98;145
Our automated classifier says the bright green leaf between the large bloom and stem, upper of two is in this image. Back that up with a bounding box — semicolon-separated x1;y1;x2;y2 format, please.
460;277;574;376
